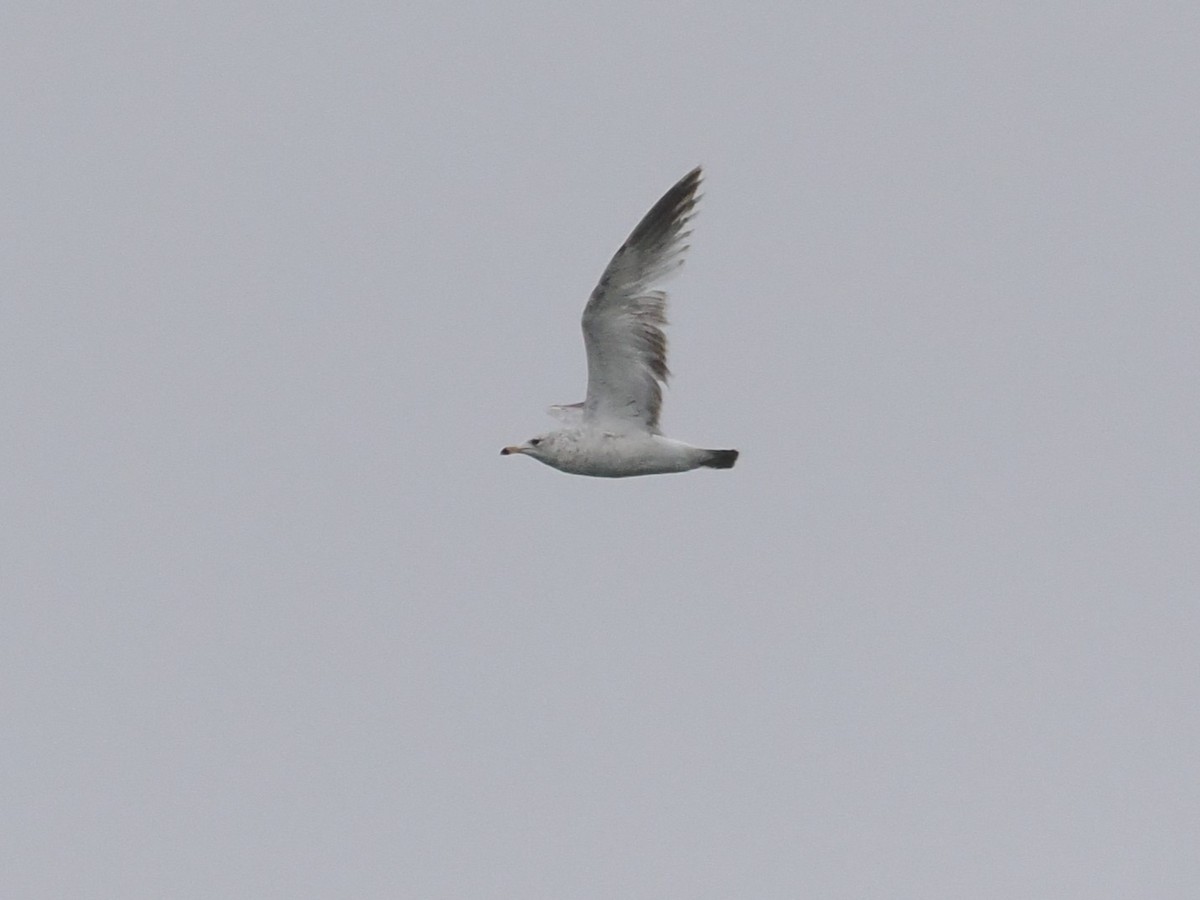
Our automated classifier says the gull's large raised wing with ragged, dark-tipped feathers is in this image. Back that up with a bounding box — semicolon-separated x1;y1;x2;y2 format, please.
583;167;701;433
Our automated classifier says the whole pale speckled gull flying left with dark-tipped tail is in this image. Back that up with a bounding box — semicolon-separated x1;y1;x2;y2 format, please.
500;167;738;478
